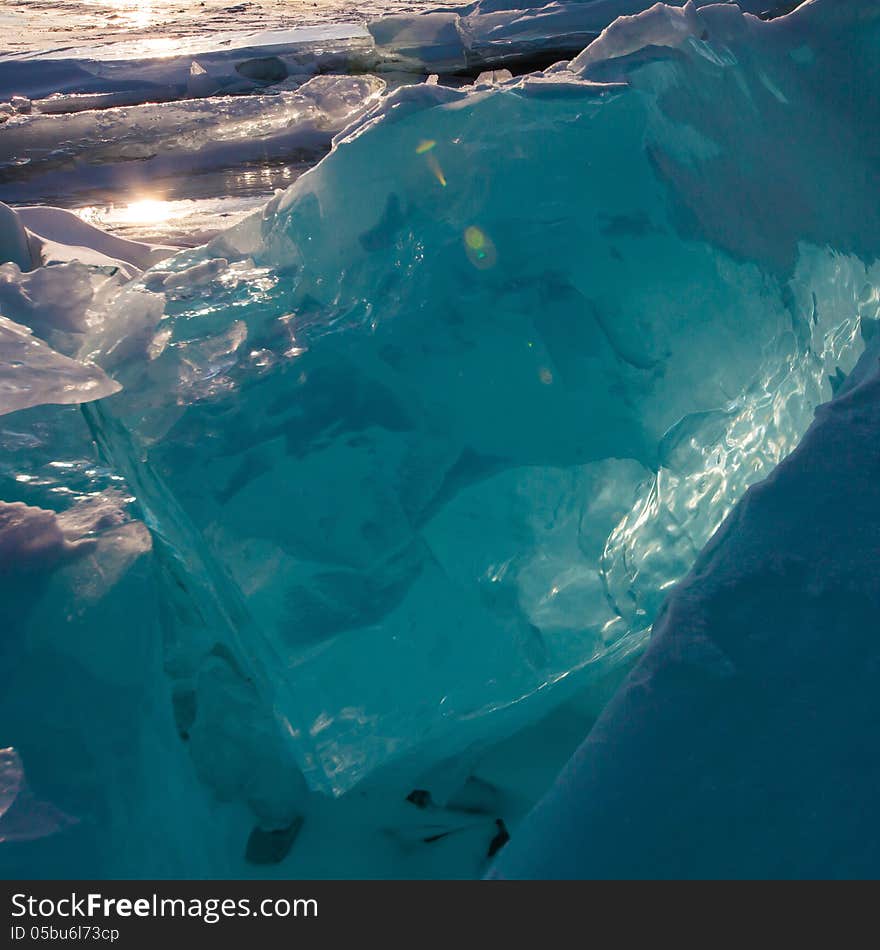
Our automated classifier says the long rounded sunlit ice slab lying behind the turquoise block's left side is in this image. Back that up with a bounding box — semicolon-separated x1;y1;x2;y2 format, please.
0;76;385;201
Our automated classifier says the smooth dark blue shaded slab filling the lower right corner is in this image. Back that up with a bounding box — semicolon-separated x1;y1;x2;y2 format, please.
494;336;880;879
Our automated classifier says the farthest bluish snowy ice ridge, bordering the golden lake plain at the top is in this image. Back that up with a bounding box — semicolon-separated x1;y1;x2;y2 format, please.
0;0;792;110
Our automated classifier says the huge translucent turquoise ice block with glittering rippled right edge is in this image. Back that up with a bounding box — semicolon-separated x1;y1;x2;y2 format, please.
70;3;880;793
